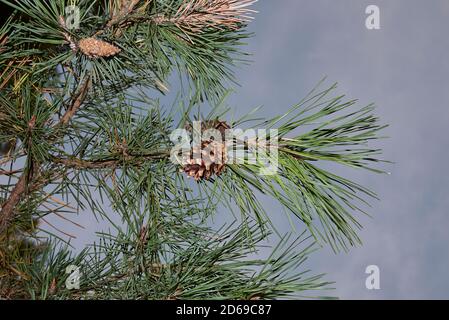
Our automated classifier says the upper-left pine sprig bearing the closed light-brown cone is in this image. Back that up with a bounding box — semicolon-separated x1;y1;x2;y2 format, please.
2;0;253;99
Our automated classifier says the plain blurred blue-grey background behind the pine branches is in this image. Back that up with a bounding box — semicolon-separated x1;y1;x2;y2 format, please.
43;0;449;299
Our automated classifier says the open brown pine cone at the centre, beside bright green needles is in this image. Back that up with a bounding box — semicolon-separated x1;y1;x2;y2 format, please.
181;120;230;181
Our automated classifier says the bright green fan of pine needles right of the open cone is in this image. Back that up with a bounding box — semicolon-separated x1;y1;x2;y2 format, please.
197;85;386;251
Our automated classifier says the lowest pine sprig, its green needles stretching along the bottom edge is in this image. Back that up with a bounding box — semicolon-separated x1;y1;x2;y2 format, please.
12;222;331;300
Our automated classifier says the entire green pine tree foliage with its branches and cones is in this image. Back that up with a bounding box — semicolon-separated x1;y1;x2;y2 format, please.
0;0;384;299
